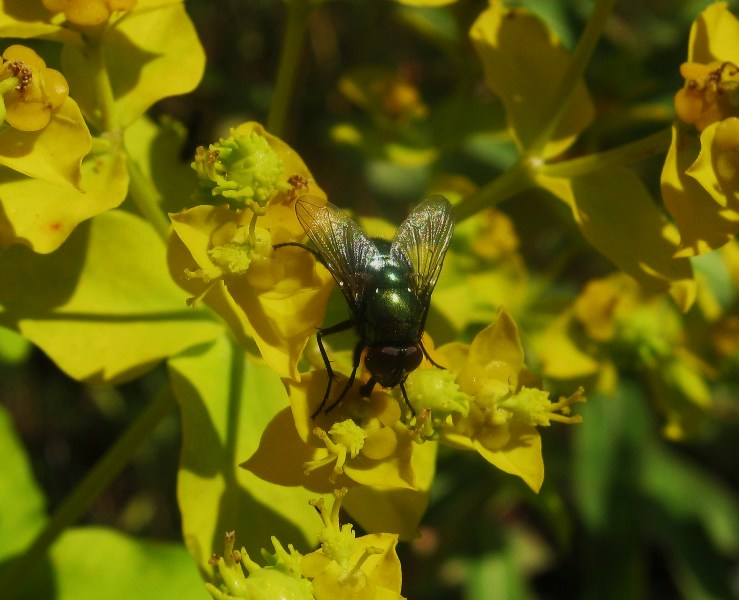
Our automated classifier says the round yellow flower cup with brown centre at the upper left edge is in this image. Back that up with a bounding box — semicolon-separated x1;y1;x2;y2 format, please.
0;45;69;131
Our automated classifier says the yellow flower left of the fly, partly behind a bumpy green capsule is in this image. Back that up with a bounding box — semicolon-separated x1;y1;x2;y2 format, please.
169;123;332;377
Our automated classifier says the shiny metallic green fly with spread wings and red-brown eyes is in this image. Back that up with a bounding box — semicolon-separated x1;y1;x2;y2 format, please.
275;196;454;418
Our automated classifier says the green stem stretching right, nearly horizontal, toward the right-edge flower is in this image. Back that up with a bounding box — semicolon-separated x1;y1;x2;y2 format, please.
537;127;672;177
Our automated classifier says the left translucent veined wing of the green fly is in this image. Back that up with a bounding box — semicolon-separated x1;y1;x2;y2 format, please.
295;196;379;312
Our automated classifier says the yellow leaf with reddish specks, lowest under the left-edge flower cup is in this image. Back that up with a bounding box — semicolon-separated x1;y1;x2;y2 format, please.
0;153;128;253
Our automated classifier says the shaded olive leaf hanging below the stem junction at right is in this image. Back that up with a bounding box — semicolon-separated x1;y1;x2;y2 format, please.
536;167;695;310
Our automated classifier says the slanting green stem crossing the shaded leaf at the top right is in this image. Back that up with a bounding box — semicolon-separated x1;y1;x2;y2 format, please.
527;0;616;156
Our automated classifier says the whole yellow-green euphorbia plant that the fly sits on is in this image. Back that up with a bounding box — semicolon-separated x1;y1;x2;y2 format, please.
0;0;739;599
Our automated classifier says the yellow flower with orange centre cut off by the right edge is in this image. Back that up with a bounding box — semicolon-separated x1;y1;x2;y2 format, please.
661;2;739;257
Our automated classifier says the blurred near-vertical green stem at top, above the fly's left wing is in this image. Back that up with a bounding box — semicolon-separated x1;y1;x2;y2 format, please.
267;0;318;136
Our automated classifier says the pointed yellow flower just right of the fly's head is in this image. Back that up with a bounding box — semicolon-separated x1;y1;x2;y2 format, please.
439;311;585;491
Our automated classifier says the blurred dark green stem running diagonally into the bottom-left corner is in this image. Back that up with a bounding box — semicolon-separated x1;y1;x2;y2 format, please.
0;387;175;597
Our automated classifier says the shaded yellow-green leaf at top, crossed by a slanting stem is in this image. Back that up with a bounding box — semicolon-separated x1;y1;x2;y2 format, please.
470;0;594;158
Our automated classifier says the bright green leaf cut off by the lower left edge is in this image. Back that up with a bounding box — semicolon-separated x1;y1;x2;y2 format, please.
0;406;46;559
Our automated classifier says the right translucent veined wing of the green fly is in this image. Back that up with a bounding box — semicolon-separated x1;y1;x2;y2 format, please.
390;196;454;304
